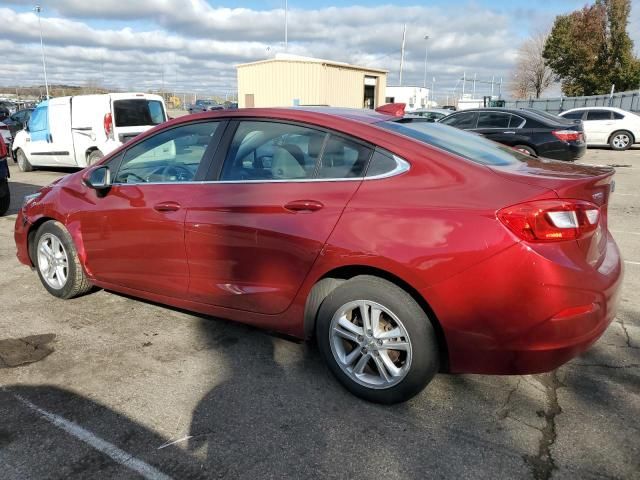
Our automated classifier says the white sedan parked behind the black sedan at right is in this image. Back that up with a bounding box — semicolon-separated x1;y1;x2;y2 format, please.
560;107;640;150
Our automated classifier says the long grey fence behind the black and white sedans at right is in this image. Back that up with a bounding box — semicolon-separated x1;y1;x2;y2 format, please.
505;90;640;114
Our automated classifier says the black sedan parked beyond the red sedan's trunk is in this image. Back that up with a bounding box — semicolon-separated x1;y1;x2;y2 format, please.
440;108;586;161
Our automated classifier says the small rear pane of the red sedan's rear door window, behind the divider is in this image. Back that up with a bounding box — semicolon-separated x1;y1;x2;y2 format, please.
317;135;371;178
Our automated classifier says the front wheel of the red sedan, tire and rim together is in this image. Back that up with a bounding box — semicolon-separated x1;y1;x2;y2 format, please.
32;220;91;299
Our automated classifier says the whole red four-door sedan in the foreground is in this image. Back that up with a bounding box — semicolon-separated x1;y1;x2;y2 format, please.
15;108;622;403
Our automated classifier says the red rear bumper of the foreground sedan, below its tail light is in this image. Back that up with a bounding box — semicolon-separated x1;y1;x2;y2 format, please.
421;236;623;374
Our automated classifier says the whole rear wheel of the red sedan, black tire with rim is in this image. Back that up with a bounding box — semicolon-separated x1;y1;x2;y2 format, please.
316;275;440;404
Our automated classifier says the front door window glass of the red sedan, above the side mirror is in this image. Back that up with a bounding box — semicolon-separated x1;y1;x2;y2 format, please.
115;122;220;183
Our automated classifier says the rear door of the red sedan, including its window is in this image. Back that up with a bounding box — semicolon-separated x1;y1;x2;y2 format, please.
185;120;372;314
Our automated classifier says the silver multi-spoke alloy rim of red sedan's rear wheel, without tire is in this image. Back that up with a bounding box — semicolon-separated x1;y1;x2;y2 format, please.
329;300;412;389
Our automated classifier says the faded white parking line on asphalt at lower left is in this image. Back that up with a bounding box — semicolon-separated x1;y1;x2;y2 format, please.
14;395;172;480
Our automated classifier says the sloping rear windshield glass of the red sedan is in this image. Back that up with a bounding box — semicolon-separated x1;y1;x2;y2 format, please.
376;120;531;165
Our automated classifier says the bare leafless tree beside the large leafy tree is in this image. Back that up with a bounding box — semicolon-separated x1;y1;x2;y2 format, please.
511;33;554;98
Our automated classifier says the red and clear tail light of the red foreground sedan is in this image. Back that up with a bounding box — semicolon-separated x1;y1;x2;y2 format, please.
498;200;600;242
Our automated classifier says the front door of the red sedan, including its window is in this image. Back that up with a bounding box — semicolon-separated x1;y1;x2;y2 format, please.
71;122;220;297
